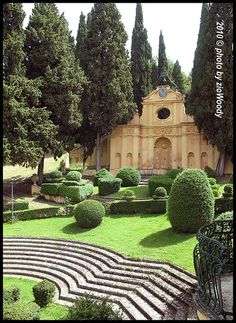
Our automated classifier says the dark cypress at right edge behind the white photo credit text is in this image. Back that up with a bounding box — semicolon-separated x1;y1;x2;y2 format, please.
186;3;233;176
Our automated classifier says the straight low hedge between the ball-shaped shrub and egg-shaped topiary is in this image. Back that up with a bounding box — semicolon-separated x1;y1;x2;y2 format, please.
110;199;167;214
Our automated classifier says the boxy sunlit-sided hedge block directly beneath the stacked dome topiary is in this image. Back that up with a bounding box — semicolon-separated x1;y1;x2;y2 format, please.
57;184;93;202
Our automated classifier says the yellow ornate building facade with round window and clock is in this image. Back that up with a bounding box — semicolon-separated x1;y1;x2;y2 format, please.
70;84;233;175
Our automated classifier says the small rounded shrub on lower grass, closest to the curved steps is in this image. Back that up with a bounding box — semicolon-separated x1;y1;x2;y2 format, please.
33;279;56;307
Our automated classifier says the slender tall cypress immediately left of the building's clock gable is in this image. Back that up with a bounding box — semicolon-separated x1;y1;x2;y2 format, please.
131;3;152;116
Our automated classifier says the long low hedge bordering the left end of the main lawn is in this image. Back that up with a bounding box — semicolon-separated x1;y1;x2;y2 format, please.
3;206;60;223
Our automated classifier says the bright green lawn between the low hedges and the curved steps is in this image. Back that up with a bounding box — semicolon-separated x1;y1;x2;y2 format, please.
3;214;197;272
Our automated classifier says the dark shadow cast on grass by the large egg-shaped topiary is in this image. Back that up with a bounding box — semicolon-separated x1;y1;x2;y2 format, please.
139;228;195;248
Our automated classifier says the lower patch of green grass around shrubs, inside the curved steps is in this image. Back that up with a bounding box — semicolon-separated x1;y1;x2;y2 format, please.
3;277;68;320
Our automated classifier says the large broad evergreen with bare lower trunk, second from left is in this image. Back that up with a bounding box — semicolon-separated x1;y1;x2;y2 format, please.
25;3;86;179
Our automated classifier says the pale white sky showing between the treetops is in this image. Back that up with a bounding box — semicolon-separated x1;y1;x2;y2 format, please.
23;2;202;74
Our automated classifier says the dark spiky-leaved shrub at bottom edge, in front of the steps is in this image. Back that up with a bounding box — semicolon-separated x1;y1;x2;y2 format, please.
67;295;123;321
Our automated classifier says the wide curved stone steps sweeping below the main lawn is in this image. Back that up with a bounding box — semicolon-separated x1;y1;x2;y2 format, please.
3;237;197;320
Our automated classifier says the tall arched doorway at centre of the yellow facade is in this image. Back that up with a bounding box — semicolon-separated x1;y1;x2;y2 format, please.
154;138;172;172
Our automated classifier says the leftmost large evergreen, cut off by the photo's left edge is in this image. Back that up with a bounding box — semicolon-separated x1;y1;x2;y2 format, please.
3;3;58;167
